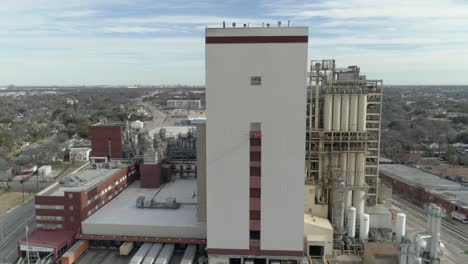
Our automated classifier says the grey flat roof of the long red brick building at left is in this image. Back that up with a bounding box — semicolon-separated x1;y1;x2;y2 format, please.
43;163;130;196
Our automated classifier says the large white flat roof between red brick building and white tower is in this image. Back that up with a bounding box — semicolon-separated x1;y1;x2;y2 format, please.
82;179;206;239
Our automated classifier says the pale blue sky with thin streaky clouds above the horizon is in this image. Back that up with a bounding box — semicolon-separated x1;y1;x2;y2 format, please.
0;0;468;85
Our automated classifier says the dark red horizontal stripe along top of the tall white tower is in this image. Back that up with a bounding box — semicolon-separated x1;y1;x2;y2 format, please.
205;36;309;44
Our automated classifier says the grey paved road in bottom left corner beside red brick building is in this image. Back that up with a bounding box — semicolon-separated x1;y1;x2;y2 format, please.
0;199;35;264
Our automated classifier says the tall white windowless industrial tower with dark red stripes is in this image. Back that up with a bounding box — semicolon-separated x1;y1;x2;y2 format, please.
206;27;308;263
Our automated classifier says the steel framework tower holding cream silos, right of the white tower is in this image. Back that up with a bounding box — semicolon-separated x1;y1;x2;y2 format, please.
306;60;383;248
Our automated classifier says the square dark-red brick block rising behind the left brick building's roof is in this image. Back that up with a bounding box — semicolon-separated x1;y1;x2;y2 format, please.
89;126;122;159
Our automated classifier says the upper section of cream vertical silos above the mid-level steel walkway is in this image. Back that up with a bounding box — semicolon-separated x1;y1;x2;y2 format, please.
323;94;367;132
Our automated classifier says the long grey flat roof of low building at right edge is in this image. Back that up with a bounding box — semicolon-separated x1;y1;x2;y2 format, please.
380;164;468;207
